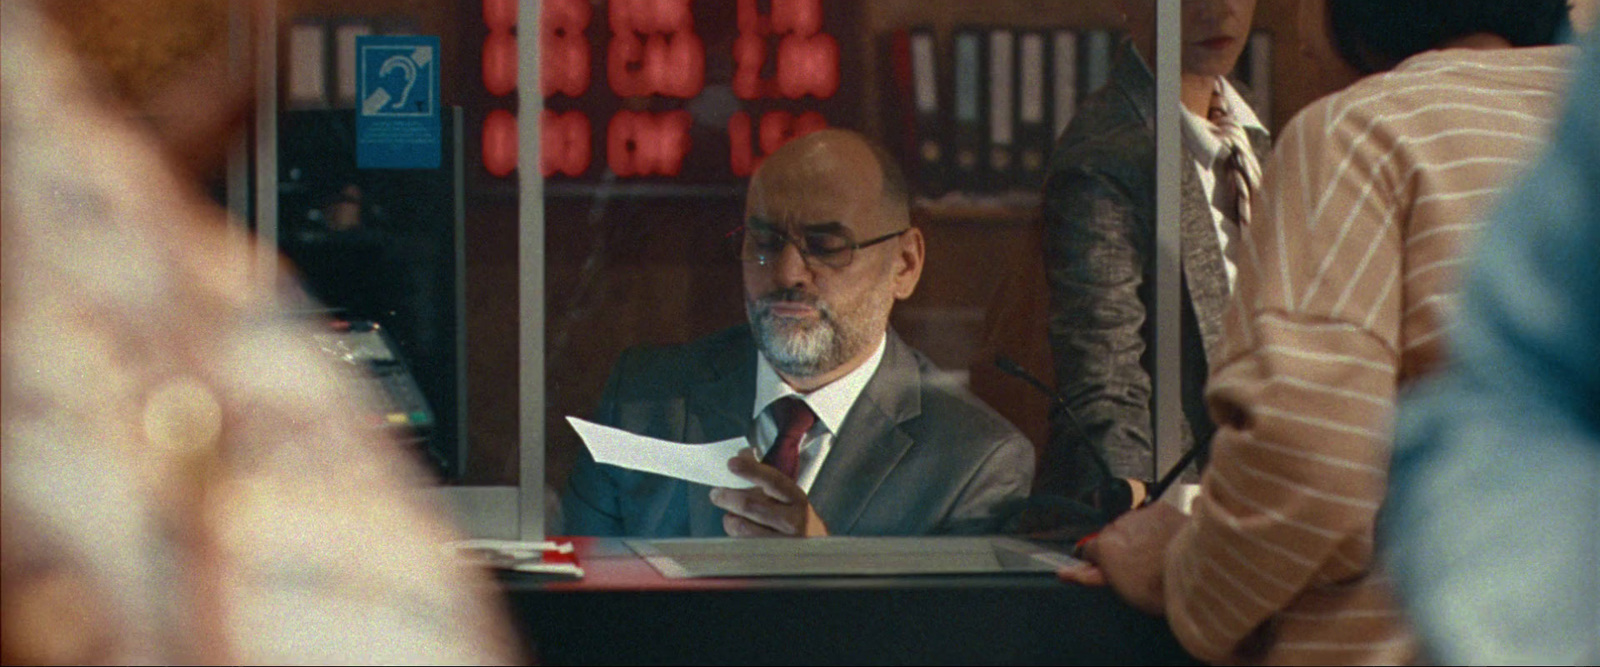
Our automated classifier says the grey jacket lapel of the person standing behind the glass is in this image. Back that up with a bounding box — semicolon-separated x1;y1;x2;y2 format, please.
1181;147;1227;368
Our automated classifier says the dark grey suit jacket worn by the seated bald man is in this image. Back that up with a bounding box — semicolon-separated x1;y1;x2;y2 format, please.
562;326;1034;537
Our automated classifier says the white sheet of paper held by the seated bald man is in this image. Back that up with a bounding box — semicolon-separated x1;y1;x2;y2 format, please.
566;417;754;489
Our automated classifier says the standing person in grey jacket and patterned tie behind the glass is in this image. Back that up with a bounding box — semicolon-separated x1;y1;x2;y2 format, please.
1038;0;1270;515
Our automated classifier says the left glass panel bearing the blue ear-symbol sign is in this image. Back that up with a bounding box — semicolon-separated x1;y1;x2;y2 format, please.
252;0;518;485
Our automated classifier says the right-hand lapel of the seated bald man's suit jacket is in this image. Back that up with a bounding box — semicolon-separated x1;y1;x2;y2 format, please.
810;331;922;534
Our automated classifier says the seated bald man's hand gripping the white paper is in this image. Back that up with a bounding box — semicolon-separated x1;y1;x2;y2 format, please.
710;449;827;537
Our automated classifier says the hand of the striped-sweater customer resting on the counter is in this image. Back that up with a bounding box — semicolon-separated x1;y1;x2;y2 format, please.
1056;502;1189;616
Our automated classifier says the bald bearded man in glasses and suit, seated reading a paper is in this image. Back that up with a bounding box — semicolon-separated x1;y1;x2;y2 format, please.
563;130;1034;537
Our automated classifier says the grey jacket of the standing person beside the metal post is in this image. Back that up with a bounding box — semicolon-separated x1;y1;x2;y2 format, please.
1035;43;1267;496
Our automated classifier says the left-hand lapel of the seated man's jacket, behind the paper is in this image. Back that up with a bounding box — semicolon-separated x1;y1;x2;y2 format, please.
682;332;755;536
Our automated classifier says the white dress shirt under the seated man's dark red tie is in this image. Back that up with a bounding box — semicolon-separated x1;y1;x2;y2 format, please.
750;336;886;493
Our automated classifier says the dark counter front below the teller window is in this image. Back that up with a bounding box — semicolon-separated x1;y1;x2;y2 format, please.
501;537;1194;665
